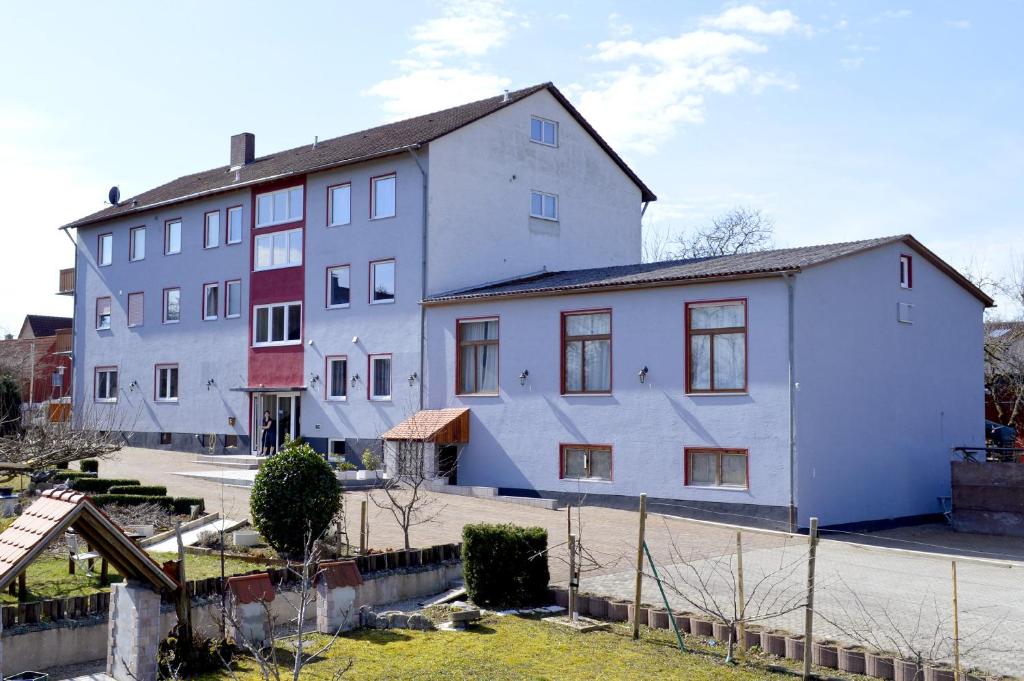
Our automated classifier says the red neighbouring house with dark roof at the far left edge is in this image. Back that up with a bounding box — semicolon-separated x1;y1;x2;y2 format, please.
0;314;72;403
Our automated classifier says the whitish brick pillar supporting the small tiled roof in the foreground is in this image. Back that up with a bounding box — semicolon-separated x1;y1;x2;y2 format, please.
106;582;160;681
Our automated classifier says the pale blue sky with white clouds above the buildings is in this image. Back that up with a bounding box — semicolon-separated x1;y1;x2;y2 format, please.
0;0;1024;334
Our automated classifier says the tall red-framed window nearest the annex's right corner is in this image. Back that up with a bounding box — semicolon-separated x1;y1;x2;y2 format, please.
686;300;746;392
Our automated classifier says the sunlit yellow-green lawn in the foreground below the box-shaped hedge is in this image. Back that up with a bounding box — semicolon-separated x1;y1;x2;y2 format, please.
203;615;806;681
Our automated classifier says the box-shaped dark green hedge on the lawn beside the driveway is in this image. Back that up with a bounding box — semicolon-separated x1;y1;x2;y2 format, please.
462;522;551;607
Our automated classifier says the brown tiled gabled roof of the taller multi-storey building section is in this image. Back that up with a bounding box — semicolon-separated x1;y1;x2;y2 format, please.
61;83;657;229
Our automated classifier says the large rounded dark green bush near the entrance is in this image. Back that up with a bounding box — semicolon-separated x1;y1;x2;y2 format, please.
249;442;341;555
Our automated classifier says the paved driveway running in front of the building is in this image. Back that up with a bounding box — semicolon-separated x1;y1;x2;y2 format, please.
100;449;1024;675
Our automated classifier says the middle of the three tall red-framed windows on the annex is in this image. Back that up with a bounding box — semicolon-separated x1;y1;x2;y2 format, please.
562;310;611;394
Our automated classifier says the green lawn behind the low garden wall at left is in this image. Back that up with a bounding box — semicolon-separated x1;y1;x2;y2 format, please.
0;553;266;603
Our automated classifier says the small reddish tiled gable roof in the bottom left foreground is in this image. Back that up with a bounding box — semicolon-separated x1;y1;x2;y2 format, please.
0;490;178;591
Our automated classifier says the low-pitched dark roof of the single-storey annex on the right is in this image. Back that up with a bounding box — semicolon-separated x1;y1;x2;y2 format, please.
424;235;993;306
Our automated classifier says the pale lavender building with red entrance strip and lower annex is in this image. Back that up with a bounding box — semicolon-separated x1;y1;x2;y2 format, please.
65;79;991;524
